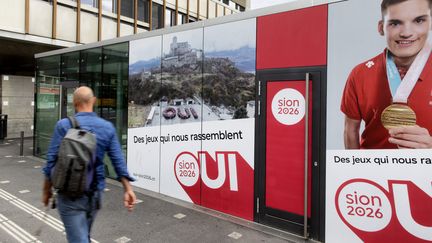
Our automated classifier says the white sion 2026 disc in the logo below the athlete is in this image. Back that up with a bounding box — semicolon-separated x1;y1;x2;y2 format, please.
336;181;392;232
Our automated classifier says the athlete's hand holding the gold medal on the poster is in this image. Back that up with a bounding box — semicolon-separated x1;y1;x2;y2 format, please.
389;125;432;149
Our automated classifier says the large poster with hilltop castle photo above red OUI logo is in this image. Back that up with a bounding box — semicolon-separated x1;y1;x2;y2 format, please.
128;19;256;220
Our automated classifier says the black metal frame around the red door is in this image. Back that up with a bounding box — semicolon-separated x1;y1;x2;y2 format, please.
254;66;327;240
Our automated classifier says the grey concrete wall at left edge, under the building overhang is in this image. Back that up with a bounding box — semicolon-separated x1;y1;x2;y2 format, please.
0;75;34;138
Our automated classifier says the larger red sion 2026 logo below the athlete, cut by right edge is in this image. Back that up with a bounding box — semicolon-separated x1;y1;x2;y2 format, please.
335;179;432;242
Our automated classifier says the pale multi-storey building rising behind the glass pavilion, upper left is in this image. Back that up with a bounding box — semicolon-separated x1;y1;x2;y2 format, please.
0;0;246;138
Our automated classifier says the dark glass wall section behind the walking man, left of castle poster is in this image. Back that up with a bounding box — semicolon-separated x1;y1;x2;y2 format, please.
34;42;129;177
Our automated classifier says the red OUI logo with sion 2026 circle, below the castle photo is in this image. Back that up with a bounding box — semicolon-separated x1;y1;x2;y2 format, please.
174;151;254;220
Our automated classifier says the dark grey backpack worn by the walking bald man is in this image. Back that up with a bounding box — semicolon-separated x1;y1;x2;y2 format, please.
51;116;96;198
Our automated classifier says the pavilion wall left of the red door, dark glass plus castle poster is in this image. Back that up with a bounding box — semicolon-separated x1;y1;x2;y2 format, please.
35;16;256;226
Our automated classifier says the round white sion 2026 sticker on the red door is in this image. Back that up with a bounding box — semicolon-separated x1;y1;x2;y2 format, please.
272;88;305;125
